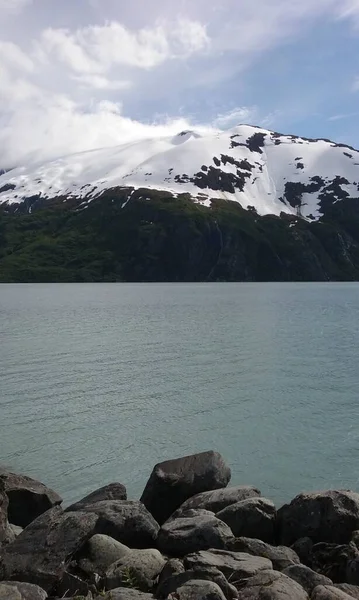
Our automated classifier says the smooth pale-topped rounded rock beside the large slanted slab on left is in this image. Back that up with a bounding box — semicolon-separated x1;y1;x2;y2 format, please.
78;534;130;577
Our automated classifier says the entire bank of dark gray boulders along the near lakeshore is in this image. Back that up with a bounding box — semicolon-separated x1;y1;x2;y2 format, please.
0;452;359;600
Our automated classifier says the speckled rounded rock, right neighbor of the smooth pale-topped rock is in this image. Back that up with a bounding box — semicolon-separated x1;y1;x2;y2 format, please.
105;549;166;592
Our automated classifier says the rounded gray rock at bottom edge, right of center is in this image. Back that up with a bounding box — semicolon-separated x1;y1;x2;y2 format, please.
240;571;309;600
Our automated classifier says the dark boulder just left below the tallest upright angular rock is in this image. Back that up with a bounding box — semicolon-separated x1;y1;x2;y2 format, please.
83;500;159;548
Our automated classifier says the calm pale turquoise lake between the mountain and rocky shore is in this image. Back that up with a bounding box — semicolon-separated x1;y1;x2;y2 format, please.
0;283;359;505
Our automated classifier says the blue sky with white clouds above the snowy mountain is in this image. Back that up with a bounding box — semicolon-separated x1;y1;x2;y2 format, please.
0;0;359;167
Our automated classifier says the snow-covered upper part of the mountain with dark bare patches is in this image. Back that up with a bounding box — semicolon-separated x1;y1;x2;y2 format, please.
0;125;359;219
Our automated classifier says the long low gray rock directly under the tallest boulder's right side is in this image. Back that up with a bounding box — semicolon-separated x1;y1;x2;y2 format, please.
178;485;261;513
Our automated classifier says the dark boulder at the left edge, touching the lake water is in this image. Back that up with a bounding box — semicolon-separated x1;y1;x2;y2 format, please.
0;470;62;527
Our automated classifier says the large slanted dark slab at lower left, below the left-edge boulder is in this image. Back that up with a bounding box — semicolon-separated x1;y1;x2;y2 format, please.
0;507;98;592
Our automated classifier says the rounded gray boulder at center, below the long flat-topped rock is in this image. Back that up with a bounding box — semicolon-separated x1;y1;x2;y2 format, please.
157;513;233;556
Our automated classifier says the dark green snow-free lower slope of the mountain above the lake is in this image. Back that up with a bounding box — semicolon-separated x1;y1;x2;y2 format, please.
0;188;359;282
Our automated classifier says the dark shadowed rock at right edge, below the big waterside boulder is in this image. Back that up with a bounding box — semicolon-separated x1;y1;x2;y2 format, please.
311;542;357;583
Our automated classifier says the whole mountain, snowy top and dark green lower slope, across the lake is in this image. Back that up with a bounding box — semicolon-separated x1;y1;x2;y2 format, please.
0;125;359;281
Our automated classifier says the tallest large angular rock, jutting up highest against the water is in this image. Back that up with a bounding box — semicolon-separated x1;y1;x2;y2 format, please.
141;452;231;525
